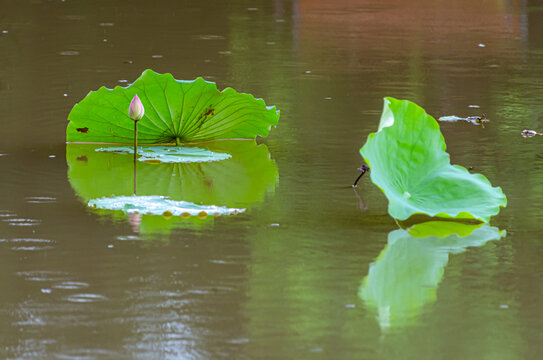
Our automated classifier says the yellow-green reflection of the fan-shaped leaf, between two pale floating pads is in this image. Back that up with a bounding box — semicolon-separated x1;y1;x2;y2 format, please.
66;140;278;208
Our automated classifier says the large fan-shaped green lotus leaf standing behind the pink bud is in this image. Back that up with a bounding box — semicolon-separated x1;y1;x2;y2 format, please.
66;70;279;144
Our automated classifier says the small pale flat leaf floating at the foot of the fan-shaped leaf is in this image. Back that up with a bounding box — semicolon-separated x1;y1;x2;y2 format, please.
96;146;232;163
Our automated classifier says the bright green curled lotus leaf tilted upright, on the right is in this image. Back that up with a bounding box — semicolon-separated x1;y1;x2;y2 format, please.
360;98;507;221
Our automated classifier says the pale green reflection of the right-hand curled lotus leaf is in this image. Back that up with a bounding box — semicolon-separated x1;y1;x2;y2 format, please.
359;222;505;329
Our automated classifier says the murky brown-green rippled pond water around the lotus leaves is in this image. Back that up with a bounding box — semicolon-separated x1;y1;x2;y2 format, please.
0;0;543;359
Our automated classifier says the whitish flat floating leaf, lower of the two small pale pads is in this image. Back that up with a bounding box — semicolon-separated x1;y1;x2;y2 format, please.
88;196;245;217
